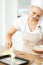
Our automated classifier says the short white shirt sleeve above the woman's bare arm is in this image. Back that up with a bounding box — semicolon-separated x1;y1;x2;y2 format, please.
13;16;26;30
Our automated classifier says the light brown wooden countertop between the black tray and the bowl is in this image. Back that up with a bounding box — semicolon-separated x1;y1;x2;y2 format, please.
0;46;40;65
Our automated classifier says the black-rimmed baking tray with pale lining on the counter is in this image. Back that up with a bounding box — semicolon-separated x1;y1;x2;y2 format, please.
0;55;30;65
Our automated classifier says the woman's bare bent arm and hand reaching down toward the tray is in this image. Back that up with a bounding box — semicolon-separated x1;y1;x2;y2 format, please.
5;26;17;49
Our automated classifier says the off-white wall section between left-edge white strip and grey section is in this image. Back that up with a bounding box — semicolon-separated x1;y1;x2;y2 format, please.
6;0;17;32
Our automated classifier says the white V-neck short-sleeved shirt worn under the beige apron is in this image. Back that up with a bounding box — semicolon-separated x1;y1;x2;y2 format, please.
14;15;43;33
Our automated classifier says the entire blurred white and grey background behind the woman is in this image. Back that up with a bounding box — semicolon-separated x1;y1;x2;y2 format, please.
0;0;31;48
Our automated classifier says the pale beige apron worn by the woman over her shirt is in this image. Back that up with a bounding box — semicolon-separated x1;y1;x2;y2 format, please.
22;23;43;53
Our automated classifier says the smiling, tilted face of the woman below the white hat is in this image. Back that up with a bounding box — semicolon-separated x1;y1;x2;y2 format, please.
30;6;43;22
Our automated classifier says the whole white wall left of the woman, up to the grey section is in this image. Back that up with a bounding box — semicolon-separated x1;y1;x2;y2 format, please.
0;0;17;45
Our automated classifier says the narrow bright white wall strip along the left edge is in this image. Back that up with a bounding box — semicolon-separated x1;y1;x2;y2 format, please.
0;0;5;45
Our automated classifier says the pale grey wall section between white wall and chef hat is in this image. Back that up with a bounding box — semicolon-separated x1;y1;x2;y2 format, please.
17;0;31;16
